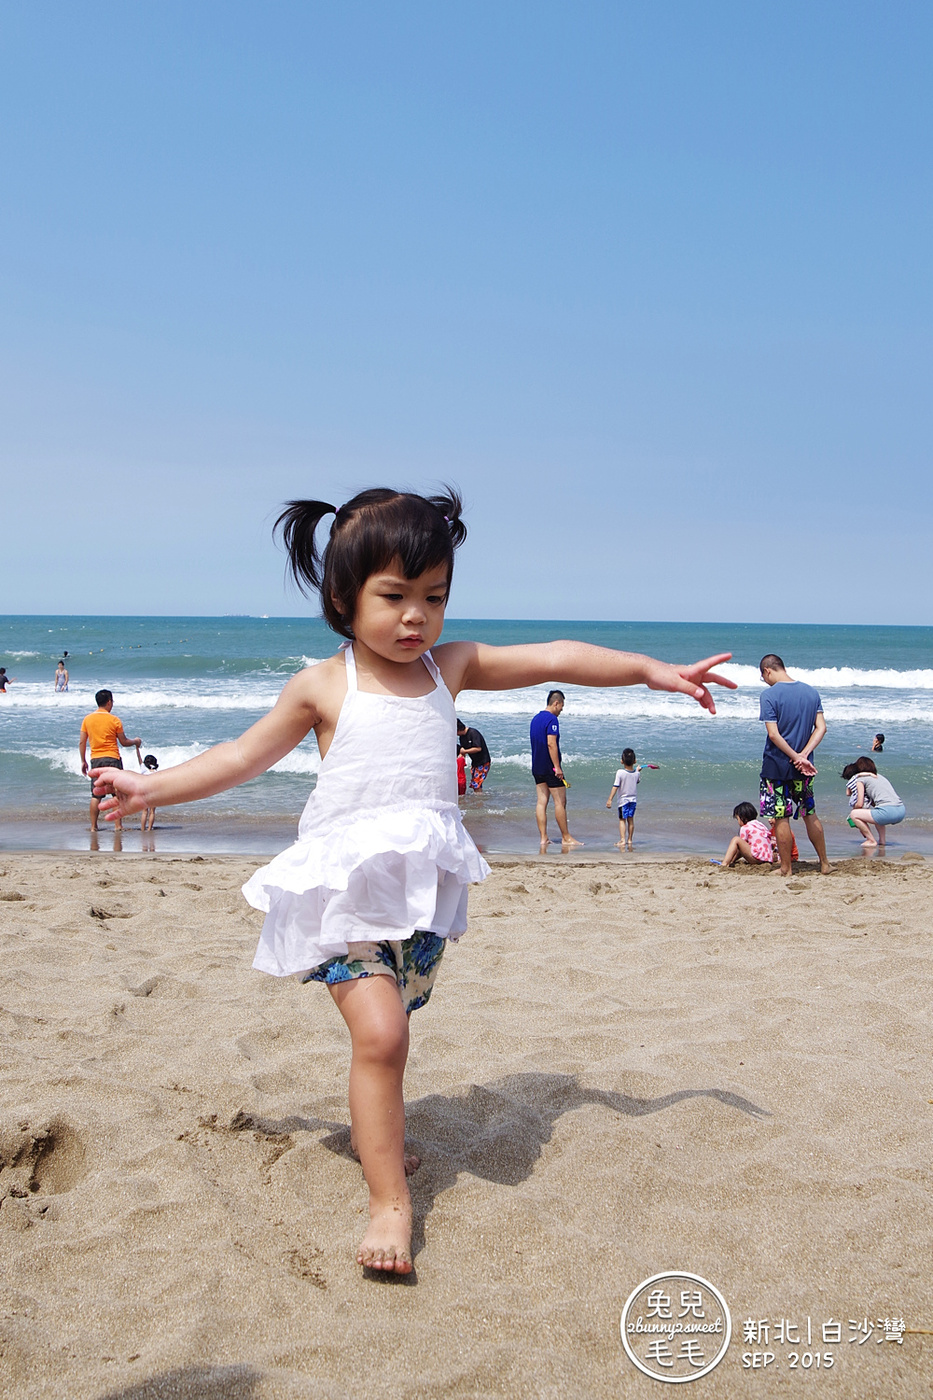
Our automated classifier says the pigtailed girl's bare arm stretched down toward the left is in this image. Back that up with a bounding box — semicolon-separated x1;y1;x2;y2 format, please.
92;666;321;822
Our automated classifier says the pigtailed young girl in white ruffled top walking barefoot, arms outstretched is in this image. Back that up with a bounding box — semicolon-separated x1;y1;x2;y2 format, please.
95;490;733;1274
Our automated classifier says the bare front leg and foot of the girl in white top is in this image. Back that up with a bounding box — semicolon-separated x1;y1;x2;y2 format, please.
331;976;412;1274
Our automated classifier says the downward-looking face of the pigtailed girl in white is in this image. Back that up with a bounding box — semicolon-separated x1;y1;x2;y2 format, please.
353;561;447;664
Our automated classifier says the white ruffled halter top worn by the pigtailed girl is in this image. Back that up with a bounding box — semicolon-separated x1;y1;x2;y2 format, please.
242;643;489;977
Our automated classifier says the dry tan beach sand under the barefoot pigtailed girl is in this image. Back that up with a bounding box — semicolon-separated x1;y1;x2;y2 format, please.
0;854;933;1400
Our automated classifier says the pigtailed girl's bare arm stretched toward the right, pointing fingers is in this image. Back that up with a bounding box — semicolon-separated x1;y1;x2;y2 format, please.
434;641;735;714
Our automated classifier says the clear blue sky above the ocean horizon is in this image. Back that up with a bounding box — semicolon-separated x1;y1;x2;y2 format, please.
0;0;933;623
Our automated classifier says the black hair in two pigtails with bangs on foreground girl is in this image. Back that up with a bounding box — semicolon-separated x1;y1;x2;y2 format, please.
273;486;467;641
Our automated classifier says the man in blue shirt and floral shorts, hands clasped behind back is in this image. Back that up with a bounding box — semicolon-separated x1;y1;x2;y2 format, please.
758;652;832;875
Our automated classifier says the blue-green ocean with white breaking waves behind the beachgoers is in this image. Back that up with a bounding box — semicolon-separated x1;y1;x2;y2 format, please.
0;616;933;858
